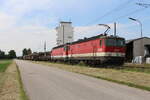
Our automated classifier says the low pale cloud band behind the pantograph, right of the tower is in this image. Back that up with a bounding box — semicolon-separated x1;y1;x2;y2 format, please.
74;23;140;40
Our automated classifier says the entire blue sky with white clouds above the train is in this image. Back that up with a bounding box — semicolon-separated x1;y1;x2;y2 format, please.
0;0;150;56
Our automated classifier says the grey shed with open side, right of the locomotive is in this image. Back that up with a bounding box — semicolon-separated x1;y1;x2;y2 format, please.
126;37;150;62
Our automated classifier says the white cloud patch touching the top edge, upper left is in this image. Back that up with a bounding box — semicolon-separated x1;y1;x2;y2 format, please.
3;0;52;15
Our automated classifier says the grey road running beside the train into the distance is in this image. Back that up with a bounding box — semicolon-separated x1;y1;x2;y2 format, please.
16;60;150;100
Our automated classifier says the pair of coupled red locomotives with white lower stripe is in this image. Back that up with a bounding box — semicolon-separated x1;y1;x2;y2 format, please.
51;34;125;65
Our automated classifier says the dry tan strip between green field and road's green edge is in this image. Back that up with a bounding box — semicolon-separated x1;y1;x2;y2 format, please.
0;62;21;100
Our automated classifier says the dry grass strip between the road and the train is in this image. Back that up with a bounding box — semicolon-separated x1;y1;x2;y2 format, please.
36;62;150;91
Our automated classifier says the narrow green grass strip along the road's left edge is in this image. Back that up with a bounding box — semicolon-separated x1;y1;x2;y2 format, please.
16;65;29;100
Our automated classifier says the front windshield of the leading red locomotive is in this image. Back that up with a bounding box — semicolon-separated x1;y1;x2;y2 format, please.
105;39;125;46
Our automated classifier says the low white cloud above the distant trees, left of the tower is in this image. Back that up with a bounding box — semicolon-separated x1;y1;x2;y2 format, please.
0;26;56;55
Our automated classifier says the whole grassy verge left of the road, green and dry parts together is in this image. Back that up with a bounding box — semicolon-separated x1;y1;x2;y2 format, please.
0;60;27;100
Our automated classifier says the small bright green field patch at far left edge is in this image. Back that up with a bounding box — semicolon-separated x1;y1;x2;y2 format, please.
0;60;12;72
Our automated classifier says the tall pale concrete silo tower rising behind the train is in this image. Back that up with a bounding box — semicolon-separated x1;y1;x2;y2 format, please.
56;22;73;45
